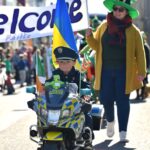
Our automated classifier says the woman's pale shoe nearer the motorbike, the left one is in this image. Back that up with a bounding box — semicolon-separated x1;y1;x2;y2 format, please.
107;121;115;137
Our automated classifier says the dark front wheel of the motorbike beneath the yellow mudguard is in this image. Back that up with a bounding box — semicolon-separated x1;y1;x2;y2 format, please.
42;141;66;150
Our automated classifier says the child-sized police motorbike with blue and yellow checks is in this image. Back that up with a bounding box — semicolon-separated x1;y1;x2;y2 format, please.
27;75;92;150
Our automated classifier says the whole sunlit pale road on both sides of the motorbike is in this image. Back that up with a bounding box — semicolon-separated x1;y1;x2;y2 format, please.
0;88;150;150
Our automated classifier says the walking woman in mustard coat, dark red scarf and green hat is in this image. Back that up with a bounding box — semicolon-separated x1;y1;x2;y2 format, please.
86;0;146;142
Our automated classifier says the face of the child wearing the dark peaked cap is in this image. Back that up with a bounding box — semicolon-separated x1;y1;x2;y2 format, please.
57;60;76;74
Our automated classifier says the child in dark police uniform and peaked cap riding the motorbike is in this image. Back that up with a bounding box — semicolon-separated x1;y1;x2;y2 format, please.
46;46;94;150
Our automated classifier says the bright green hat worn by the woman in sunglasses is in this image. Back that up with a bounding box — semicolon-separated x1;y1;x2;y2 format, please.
103;0;139;19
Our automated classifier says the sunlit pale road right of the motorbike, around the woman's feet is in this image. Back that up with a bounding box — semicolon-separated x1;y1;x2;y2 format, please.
94;92;150;150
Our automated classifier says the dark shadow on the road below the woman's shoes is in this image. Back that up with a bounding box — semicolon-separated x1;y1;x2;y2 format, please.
94;140;136;150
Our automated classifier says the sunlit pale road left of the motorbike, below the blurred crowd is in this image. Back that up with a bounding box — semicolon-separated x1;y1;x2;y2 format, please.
0;85;37;150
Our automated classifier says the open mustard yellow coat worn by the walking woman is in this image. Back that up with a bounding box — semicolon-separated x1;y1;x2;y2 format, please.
86;20;146;94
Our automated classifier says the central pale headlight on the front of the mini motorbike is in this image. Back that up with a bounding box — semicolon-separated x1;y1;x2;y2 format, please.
47;110;60;125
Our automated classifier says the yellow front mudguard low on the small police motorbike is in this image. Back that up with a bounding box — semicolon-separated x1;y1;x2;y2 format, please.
43;131;63;141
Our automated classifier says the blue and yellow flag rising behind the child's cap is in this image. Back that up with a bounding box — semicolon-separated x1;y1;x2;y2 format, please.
52;0;80;69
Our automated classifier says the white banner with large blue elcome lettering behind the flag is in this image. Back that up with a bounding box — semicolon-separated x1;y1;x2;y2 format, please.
0;0;88;43
